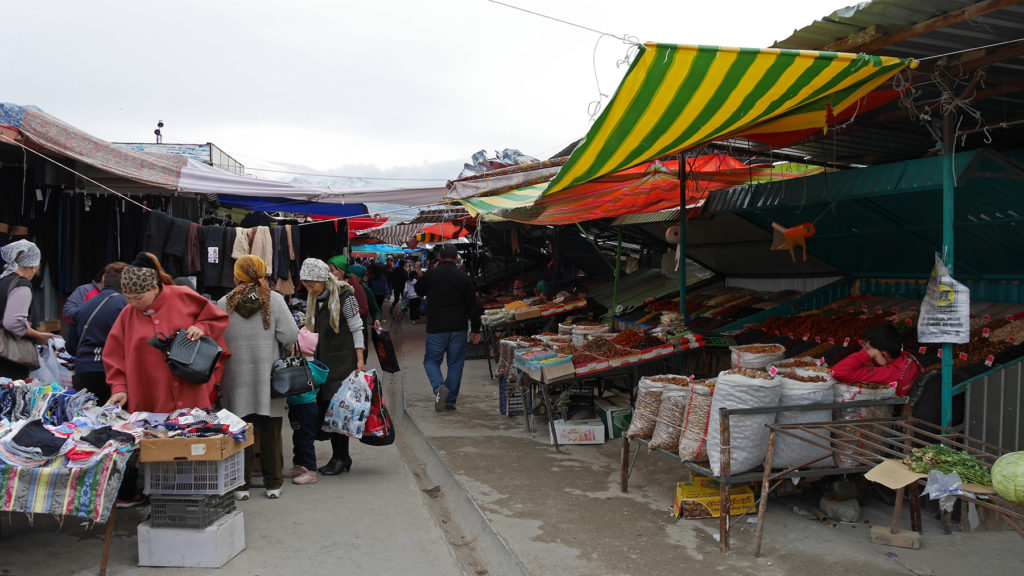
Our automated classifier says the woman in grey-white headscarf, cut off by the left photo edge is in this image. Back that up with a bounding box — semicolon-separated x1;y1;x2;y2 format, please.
0;240;53;380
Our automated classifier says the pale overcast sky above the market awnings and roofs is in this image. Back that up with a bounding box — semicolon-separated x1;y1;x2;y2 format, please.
8;0;854;186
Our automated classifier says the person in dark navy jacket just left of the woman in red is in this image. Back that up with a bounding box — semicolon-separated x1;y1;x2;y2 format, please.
67;262;128;406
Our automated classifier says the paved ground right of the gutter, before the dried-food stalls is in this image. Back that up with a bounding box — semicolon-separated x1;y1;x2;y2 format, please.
394;315;1024;576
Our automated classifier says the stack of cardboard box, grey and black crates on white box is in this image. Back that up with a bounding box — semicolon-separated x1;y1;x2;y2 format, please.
138;425;252;568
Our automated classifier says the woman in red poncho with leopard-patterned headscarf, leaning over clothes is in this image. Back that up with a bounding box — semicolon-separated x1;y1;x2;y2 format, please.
103;252;230;412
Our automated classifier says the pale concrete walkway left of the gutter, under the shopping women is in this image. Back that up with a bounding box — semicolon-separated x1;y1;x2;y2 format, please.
0;327;462;576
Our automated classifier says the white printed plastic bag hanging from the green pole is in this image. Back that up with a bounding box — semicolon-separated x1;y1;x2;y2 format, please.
918;253;971;344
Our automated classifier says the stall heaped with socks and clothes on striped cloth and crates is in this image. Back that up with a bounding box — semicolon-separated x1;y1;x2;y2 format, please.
0;379;252;574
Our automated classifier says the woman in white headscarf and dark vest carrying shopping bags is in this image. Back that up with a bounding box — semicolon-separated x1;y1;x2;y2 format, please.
299;258;366;476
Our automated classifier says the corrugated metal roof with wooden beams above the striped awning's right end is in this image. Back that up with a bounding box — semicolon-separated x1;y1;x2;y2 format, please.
754;0;1024;165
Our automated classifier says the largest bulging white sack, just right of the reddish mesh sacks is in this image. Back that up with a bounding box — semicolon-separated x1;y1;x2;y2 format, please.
708;371;782;476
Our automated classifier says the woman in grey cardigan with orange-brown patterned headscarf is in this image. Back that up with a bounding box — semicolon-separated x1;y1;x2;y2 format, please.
217;254;299;500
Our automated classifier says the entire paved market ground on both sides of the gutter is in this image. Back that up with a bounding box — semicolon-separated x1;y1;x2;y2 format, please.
0;309;1024;576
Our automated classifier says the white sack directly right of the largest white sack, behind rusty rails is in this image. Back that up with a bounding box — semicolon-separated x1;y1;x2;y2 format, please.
771;377;835;468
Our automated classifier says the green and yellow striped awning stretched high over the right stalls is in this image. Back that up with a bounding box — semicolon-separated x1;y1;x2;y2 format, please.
543;43;915;196
